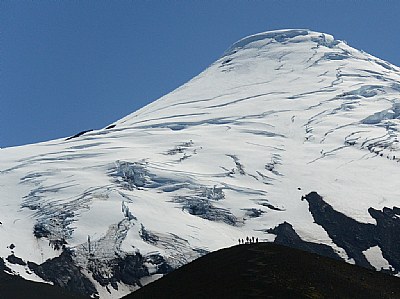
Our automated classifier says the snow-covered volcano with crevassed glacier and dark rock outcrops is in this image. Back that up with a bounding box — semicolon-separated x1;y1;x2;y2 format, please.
0;30;400;298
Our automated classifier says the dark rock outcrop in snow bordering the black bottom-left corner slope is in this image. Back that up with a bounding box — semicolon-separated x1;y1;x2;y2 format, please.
28;250;97;297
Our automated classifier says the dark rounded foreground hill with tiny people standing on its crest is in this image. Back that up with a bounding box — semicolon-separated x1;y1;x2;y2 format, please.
124;243;400;299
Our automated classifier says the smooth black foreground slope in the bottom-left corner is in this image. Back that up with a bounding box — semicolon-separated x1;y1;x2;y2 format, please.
0;259;89;299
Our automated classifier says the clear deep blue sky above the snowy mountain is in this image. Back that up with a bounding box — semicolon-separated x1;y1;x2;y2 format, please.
0;0;400;147
